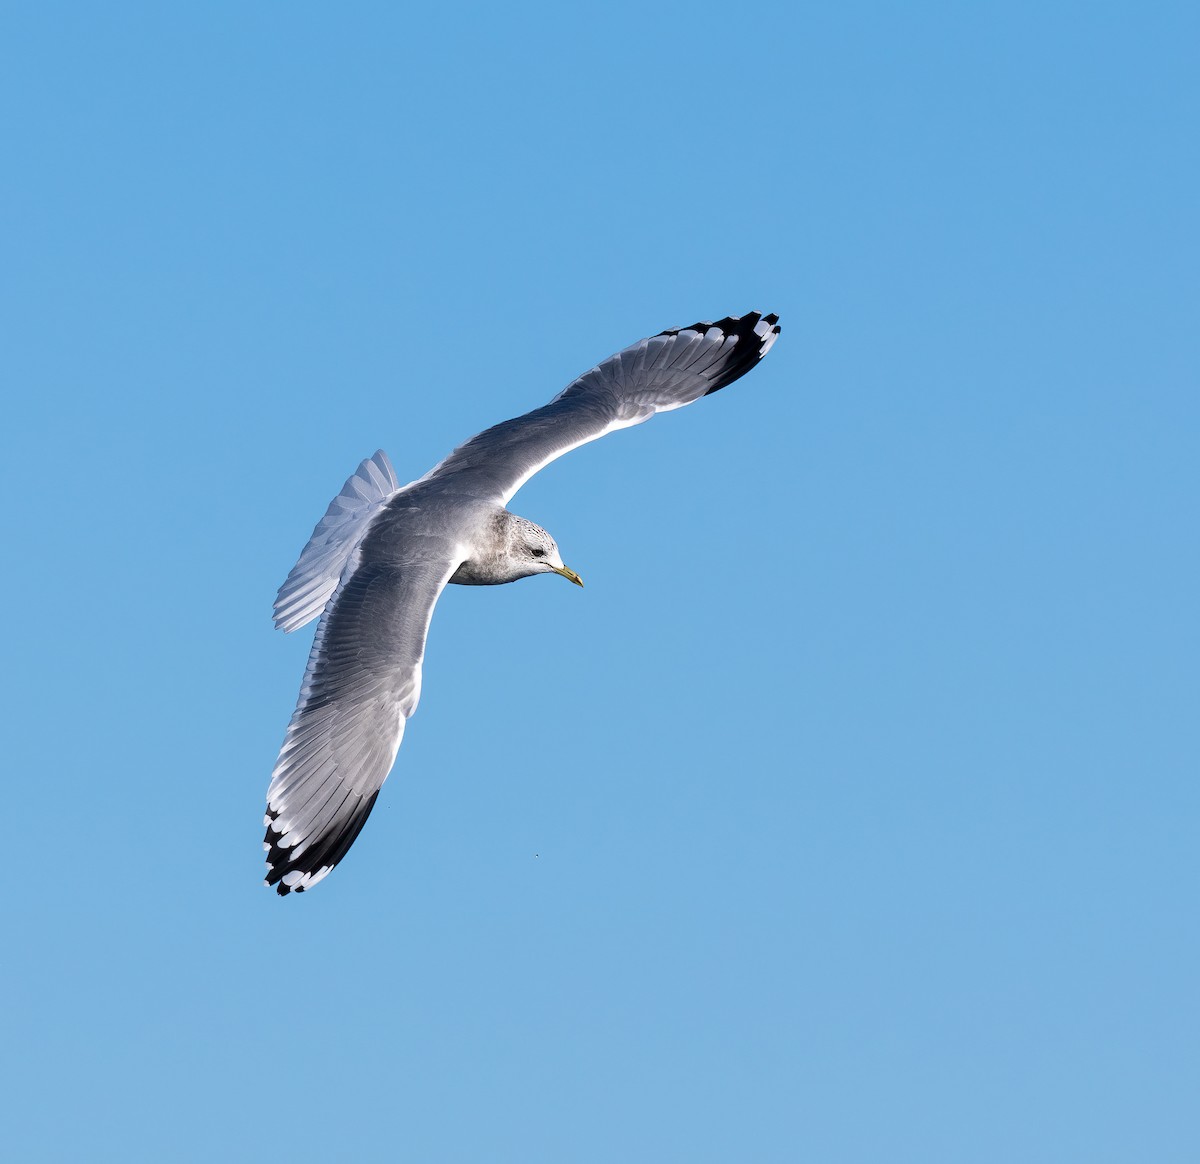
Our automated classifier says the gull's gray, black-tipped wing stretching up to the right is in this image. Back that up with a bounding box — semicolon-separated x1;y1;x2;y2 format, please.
424;311;779;505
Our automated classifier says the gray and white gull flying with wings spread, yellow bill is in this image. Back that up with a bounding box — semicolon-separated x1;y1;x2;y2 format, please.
263;312;779;895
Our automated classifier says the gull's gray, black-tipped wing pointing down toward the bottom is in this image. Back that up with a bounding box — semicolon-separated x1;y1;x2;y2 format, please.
264;562;458;894
